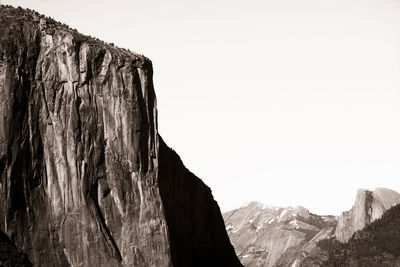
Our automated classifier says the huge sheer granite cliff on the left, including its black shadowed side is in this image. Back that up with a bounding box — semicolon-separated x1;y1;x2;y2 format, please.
0;6;241;267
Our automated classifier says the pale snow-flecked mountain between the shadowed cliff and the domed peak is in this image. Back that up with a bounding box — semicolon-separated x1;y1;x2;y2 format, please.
223;202;336;267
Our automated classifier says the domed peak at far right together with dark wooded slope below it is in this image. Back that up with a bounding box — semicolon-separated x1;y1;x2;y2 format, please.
300;188;400;267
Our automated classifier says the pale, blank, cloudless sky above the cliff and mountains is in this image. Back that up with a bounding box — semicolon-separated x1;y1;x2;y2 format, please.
1;0;400;215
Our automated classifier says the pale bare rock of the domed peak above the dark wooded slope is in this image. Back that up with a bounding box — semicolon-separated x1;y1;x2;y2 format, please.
335;188;400;243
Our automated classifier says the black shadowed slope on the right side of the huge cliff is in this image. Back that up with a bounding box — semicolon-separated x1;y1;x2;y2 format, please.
158;138;241;267
